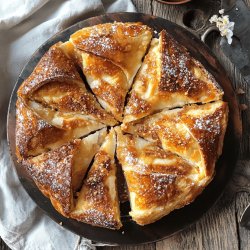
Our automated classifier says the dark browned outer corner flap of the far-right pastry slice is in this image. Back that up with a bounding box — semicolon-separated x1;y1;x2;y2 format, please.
180;101;228;175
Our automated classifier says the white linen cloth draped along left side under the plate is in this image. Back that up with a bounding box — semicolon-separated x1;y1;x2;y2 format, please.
0;0;135;250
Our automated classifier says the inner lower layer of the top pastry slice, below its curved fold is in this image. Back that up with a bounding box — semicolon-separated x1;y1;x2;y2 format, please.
82;52;130;121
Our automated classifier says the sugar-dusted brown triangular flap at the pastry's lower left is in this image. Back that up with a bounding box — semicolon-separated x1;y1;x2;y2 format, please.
22;139;81;216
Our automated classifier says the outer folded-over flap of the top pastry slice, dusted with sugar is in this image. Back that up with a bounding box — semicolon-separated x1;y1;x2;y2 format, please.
70;22;152;84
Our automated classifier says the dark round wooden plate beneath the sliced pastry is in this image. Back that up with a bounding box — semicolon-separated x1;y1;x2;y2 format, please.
7;13;241;245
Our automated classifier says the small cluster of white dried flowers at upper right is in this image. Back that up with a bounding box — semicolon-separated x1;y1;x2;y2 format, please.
209;9;234;44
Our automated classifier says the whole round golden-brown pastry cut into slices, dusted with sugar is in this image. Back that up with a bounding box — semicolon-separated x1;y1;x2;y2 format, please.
16;22;228;229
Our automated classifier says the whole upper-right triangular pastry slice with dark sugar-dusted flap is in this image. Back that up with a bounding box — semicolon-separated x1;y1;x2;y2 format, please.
124;30;223;122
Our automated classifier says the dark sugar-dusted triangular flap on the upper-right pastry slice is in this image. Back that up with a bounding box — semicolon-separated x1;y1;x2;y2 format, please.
159;30;223;96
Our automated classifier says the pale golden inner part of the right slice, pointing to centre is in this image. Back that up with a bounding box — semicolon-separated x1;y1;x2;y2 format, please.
122;109;203;171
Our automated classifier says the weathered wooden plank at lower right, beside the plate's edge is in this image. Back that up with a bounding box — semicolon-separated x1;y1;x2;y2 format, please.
156;190;239;250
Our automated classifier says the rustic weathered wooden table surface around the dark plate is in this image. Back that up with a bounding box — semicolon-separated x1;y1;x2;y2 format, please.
0;0;250;250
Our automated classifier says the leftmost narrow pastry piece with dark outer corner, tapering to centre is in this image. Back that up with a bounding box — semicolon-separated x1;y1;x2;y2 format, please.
16;98;105;161
